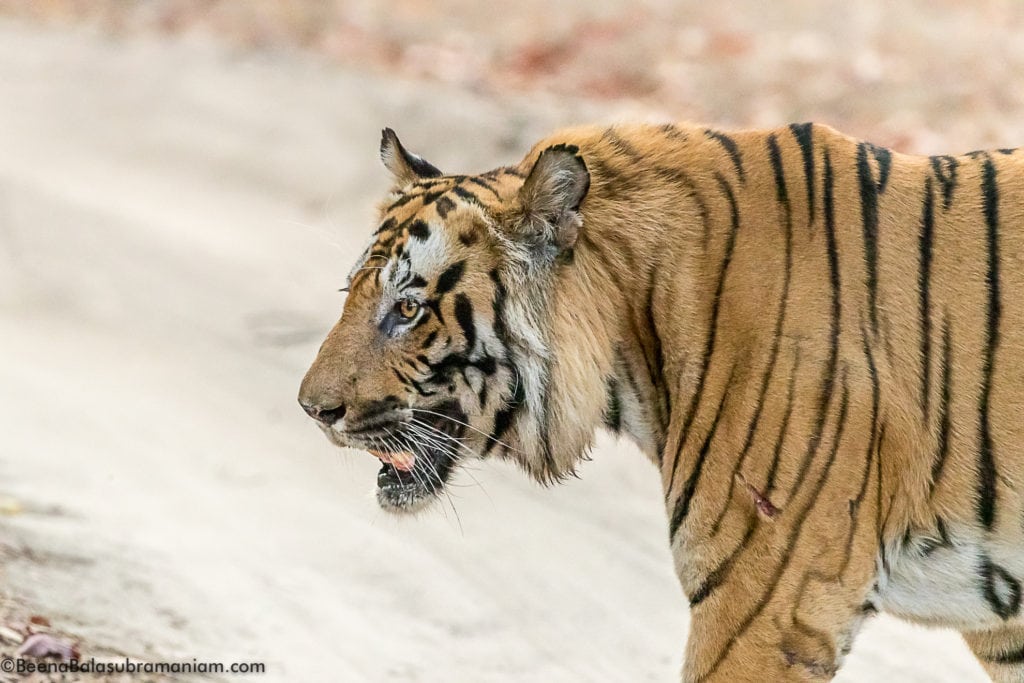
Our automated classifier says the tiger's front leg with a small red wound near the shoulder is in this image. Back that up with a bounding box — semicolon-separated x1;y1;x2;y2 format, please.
674;401;882;683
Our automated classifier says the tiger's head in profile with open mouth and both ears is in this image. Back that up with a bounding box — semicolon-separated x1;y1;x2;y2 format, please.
299;129;606;512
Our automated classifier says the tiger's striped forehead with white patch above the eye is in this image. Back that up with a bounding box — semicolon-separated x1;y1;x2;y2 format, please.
349;167;523;289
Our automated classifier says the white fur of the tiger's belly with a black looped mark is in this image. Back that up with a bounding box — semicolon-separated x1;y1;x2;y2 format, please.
872;526;1024;631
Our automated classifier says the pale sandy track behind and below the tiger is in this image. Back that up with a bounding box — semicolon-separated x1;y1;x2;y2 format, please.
0;22;1003;683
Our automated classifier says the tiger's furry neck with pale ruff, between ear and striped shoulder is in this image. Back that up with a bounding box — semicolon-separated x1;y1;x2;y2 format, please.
507;125;786;481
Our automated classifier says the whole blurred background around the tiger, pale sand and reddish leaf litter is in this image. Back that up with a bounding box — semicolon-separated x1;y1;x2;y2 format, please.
0;0;1024;682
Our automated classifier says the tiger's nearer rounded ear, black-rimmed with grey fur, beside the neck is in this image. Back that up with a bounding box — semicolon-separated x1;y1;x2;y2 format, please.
519;144;590;252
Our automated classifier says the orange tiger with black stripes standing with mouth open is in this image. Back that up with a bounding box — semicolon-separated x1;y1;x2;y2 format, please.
299;123;1024;682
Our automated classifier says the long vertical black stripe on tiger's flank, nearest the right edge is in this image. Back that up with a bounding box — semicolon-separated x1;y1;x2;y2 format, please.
978;157;1001;529
